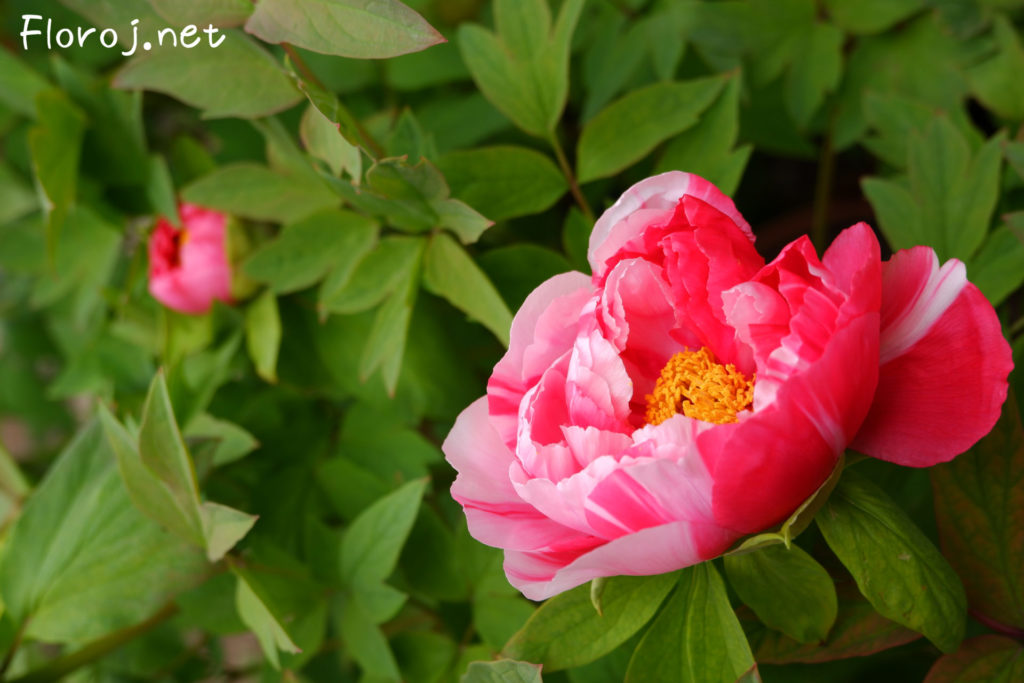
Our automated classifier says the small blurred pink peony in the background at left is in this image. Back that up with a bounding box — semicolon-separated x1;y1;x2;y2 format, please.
150;198;231;314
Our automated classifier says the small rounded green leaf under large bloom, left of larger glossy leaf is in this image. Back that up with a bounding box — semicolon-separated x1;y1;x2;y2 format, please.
725;546;838;643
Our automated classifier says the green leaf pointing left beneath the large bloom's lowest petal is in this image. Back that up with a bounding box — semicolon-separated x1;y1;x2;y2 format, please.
503;573;677;680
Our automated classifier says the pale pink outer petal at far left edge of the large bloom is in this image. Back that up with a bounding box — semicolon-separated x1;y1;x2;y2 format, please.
441;397;581;550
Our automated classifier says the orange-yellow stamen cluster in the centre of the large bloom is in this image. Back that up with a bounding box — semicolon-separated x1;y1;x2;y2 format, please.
645;346;754;425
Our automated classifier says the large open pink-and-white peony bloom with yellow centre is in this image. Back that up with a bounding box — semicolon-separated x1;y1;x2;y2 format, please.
443;172;1012;599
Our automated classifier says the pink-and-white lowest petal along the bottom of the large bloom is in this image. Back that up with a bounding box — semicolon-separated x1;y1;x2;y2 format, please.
505;521;738;600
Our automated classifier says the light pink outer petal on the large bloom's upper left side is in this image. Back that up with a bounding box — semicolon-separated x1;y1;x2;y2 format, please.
487;272;593;447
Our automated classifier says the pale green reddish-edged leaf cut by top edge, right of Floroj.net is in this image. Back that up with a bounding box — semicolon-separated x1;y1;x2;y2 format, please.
246;0;444;59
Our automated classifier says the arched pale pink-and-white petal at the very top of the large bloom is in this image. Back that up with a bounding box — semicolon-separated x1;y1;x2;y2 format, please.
587;171;754;279
